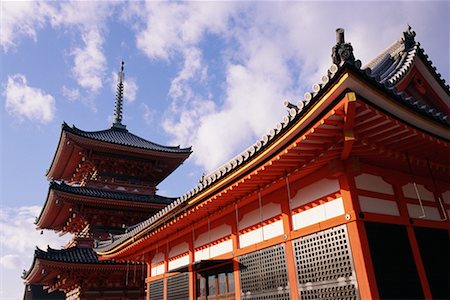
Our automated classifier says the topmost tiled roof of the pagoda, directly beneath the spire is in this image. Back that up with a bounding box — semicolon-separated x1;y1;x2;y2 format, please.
62;122;191;153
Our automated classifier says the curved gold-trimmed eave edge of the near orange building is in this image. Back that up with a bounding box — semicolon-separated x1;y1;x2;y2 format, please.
96;65;449;259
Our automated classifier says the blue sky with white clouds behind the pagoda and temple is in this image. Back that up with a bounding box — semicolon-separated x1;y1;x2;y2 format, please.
0;1;450;299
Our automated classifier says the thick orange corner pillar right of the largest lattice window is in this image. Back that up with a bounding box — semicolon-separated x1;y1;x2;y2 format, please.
339;168;380;299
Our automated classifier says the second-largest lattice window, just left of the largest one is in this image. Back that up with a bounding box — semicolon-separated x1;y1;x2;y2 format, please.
239;245;290;300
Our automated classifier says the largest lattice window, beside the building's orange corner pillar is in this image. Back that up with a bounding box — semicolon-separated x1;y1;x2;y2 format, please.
293;225;359;299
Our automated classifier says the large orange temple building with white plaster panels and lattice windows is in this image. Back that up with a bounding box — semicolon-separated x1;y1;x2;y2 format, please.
96;28;450;300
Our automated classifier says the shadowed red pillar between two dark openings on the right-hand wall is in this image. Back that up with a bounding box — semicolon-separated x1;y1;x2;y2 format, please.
392;182;433;299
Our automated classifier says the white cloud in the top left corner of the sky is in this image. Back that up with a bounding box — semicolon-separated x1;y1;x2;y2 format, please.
0;1;52;52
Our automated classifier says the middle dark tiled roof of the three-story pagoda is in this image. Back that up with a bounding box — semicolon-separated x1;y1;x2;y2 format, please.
50;181;175;204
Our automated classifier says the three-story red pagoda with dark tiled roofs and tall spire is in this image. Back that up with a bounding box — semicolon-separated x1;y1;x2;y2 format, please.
23;62;191;299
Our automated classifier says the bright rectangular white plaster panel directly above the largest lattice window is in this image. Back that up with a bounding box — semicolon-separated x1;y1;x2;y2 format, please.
292;198;345;230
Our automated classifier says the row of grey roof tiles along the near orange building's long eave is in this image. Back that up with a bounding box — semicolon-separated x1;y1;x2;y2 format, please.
96;27;450;252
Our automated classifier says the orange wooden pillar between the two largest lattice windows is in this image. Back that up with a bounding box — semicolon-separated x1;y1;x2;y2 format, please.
280;177;300;300
